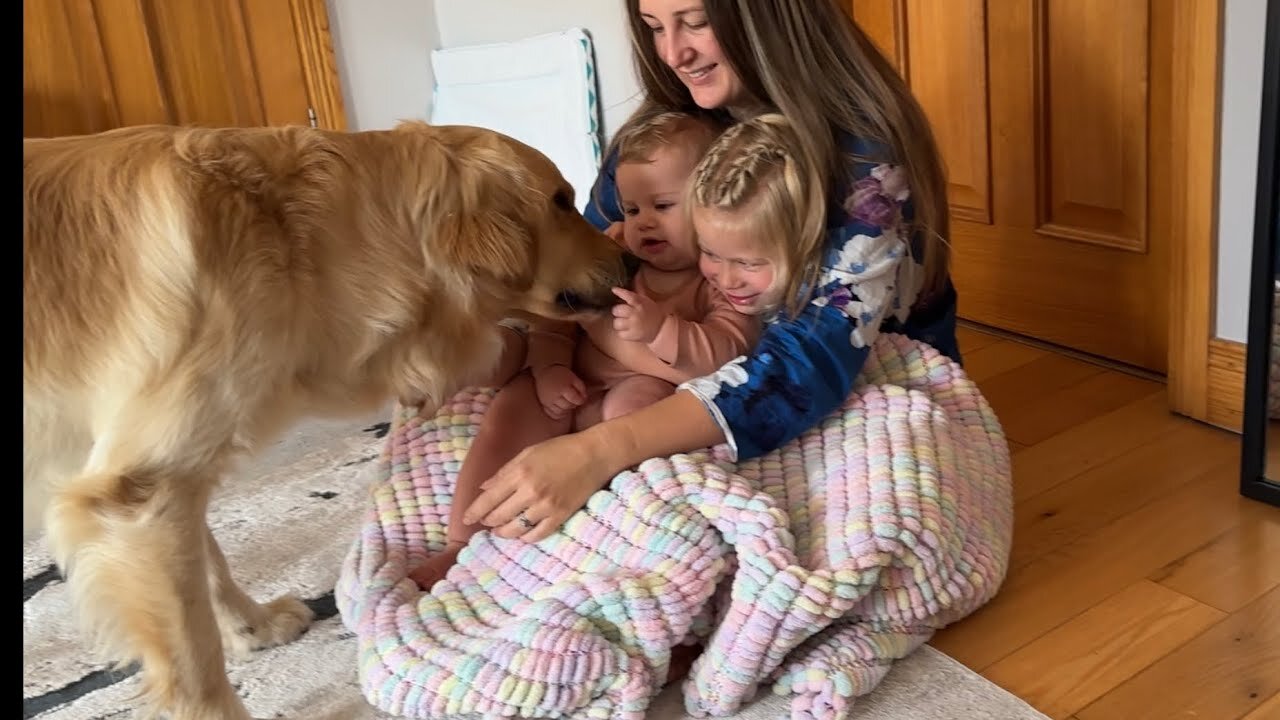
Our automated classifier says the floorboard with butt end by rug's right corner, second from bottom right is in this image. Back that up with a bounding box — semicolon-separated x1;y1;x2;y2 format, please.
983;580;1226;717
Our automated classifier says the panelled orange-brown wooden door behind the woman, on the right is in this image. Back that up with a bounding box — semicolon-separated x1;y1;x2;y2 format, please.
851;0;1172;373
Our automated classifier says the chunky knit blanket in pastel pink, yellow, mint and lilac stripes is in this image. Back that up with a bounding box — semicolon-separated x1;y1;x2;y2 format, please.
337;334;1012;719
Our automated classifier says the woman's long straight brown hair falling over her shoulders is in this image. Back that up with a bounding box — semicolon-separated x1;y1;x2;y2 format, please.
611;0;950;306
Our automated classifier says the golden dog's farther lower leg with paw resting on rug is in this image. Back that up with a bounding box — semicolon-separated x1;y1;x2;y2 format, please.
205;527;315;659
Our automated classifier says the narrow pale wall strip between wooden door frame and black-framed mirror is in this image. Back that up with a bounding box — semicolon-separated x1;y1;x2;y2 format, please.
1215;0;1267;342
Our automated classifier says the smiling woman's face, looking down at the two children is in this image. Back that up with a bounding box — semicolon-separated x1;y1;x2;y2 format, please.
640;0;746;110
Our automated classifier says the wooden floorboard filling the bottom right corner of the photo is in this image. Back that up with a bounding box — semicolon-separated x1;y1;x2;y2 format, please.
1076;588;1280;720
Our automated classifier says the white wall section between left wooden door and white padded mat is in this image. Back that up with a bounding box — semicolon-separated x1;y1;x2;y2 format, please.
326;0;440;131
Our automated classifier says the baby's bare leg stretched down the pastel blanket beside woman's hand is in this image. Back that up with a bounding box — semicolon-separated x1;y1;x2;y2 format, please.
408;372;570;589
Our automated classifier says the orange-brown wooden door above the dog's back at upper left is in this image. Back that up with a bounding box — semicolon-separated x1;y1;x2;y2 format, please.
22;0;346;137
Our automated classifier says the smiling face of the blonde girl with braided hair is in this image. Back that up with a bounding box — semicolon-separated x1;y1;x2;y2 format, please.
694;208;781;315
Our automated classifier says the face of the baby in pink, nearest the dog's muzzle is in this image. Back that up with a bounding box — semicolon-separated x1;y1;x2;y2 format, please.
617;145;699;270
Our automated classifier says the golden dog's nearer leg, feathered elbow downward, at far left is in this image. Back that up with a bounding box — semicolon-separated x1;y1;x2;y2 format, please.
47;469;248;720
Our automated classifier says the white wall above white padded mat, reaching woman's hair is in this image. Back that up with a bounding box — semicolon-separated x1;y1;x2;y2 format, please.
435;0;640;142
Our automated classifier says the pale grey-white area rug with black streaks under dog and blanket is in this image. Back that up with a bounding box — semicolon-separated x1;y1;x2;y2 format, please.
22;407;1046;720
